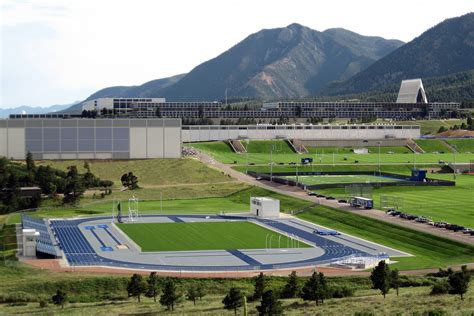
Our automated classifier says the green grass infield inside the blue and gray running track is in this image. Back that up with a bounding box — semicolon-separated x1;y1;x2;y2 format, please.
118;222;309;251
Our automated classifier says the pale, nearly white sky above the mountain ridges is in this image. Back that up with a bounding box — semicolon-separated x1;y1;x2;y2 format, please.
0;0;474;108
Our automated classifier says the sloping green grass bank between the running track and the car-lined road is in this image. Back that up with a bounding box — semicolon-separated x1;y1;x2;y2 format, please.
297;206;474;269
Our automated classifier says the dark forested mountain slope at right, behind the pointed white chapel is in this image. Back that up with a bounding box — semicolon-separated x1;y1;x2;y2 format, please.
321;13;474;95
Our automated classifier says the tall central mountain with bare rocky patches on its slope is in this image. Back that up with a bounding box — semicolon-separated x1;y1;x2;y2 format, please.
161;24;403;101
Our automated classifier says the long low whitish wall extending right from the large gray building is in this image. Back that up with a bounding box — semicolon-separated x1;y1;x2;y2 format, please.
181;125;420;142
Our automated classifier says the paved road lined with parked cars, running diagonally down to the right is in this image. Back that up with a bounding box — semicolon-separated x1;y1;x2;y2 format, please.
194;152;474;245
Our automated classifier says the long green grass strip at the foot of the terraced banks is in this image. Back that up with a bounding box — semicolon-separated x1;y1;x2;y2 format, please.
185;141;474;165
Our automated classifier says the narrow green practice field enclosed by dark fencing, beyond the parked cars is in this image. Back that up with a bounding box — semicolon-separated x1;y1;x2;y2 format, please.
280;174;400;185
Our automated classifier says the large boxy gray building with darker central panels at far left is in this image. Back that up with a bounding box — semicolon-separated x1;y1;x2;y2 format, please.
0;119;181;159
